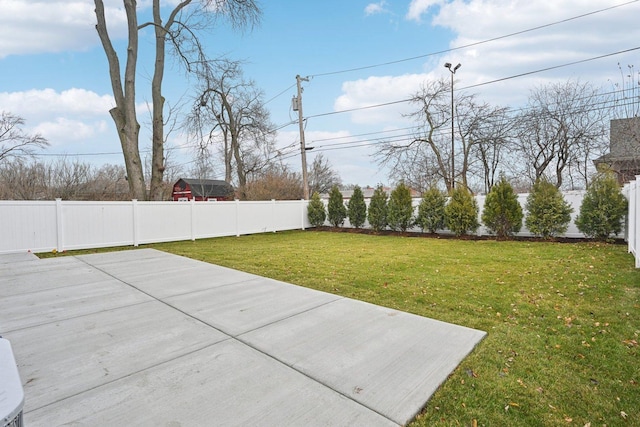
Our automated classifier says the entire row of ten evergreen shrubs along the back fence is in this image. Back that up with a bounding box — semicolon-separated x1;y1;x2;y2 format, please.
307;173;627;240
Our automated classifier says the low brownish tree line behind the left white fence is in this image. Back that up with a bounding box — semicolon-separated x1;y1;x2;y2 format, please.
0;151;341;200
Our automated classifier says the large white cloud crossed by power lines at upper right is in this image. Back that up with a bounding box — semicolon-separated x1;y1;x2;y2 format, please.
334;0;640;118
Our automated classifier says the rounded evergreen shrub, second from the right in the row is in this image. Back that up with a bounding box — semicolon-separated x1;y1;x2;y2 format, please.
525;179;573;239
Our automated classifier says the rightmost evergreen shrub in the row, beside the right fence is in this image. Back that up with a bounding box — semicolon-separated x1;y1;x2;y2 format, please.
576;173;628;240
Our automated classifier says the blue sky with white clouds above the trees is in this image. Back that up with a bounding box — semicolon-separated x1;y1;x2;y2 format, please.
0;0;640;186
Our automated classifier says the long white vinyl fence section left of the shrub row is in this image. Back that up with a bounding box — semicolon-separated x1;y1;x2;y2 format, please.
0;199;310;254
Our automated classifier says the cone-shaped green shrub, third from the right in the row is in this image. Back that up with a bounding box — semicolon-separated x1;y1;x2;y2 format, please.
482;176;523;238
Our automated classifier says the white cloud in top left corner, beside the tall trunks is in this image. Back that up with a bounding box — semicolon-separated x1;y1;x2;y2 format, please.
0;0;126;58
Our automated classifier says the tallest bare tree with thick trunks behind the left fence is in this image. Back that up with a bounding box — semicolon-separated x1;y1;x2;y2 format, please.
94;0;260;200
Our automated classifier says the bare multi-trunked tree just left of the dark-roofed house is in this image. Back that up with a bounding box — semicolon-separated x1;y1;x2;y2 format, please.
517;80;609;188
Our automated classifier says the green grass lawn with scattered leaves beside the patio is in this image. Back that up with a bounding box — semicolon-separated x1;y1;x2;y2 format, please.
42;231;640;427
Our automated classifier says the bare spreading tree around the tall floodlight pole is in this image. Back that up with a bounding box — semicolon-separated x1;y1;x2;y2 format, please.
376;79;510;191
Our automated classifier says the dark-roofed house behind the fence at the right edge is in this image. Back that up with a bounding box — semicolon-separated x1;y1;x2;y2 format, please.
593;117;640;184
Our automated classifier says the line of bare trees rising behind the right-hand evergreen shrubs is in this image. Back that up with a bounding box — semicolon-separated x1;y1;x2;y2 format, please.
376;78;640;194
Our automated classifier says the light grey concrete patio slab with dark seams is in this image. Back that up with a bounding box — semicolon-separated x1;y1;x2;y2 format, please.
0;249;485;426
